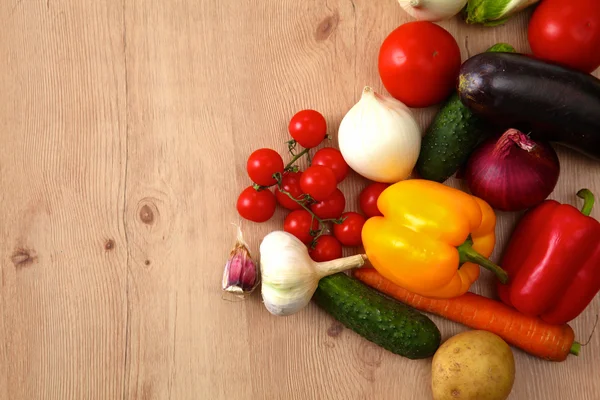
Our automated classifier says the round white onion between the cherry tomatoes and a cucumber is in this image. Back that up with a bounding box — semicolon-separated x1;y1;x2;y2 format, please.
338;86;422;183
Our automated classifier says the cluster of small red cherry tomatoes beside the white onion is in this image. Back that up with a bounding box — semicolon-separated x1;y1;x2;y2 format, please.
237;110;388;261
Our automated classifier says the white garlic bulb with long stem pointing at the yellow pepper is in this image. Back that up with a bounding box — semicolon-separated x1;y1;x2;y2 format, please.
260;231;366;316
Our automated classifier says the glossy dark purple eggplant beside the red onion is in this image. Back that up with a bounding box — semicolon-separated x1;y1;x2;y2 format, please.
458;53;600;160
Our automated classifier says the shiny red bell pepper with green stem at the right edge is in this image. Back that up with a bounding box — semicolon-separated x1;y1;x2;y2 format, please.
497;189;600;324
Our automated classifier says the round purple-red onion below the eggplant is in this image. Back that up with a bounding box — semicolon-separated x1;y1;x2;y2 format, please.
465;129;560;211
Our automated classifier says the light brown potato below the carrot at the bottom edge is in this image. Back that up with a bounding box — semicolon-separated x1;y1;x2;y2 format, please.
431;330;515;400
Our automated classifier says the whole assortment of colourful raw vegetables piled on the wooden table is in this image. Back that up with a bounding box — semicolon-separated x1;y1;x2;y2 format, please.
227;0;600;400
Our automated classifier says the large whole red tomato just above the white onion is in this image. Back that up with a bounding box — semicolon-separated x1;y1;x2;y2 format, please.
379;21;461;107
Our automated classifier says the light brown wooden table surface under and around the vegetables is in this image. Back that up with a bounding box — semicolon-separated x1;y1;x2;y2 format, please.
0;0;600;400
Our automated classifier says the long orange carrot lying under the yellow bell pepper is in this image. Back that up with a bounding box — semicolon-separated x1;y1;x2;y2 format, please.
354;267;581;361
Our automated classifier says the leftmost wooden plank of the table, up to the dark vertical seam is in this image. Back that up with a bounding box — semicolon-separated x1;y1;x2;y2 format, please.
0;1;127;399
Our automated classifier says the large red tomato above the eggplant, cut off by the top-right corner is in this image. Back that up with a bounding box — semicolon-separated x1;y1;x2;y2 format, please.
528;0;600;72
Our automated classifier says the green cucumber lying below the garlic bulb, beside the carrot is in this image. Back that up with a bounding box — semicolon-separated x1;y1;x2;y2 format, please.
313;272;441;359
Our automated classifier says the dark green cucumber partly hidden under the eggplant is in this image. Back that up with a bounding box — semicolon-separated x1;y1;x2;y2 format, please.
416;43;515;182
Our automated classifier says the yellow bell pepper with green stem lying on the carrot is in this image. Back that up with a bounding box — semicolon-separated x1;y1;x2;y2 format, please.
362;179;508;298
